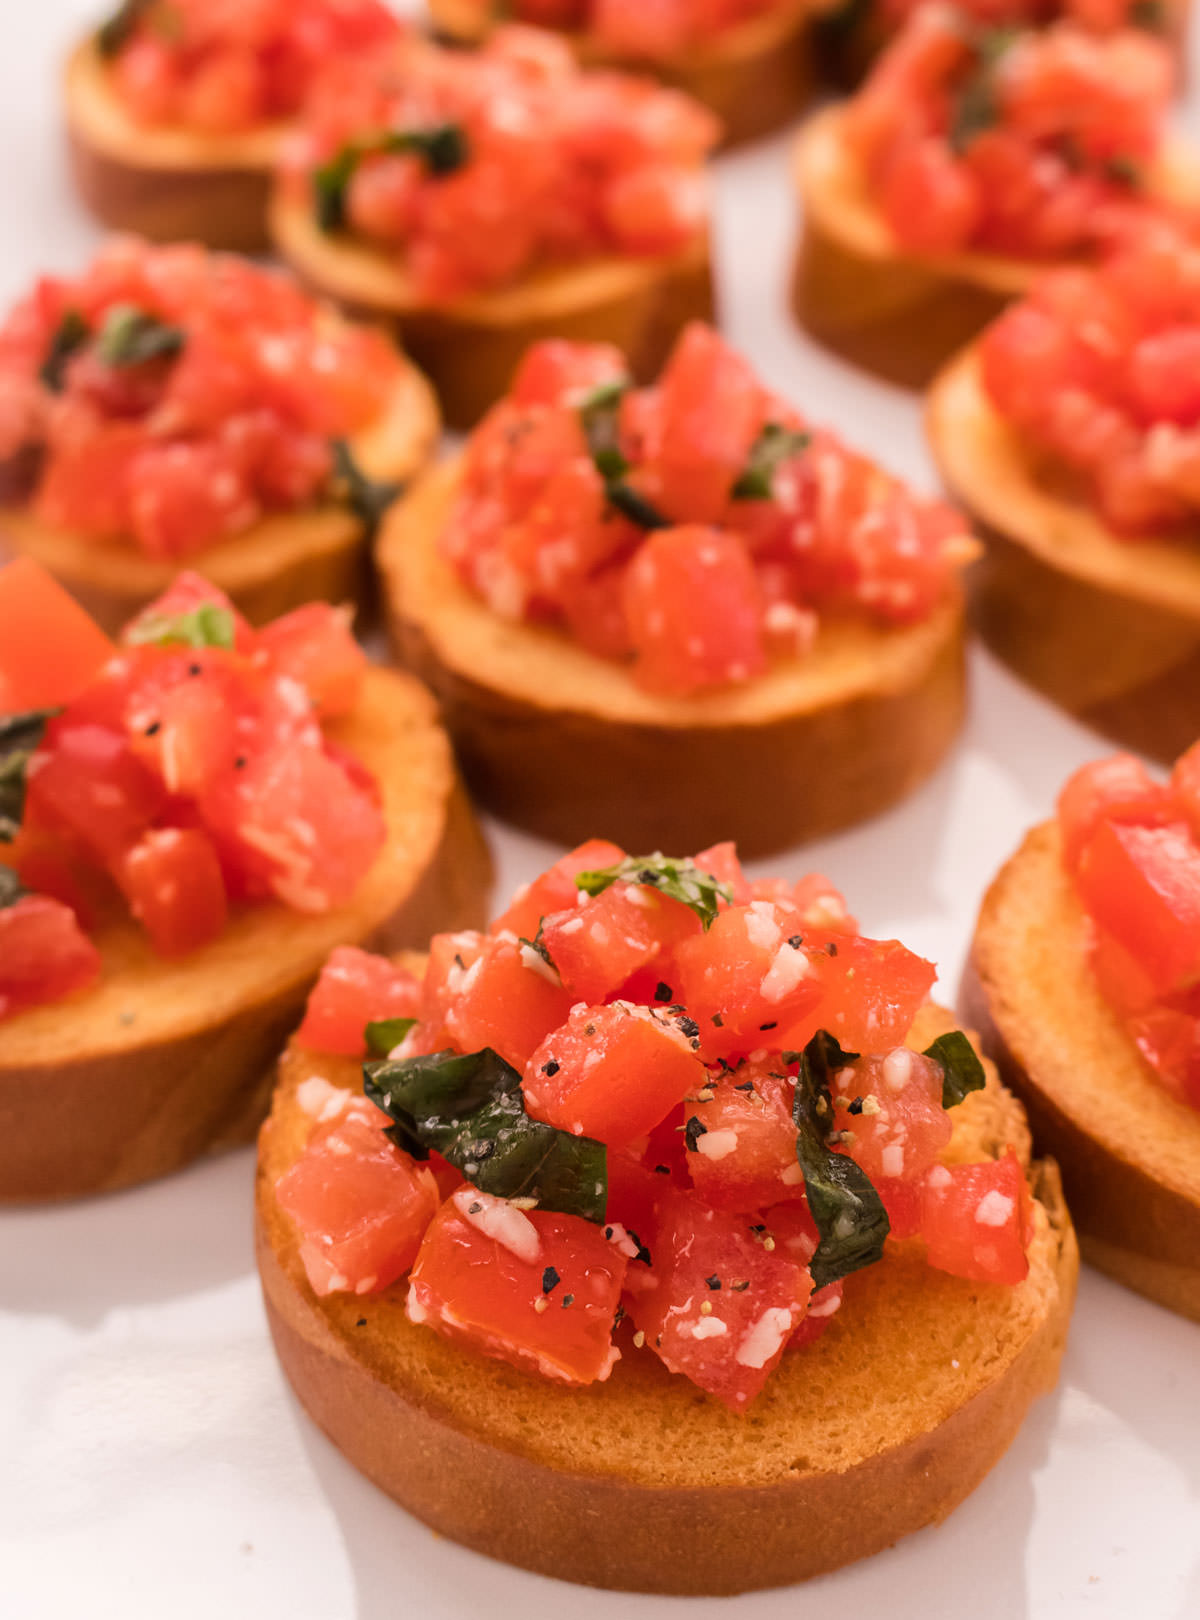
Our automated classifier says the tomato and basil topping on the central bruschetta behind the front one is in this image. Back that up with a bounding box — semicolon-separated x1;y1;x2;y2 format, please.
440;324;970;693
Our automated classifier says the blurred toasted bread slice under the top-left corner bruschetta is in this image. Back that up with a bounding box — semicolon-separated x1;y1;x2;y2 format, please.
63;39;288;253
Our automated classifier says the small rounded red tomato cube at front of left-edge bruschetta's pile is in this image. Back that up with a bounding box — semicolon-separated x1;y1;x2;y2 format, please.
117;826;228;956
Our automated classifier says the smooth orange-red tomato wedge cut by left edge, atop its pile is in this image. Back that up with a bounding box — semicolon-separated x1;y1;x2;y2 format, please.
0;557;113;714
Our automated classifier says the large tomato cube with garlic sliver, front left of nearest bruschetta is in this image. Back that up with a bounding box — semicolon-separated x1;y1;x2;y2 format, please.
408;1187;627;1385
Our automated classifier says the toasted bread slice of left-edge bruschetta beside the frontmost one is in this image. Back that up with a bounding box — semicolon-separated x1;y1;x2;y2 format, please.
0;669;491;1202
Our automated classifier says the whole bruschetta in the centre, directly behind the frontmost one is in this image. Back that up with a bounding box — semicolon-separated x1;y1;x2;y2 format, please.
377;314;975;855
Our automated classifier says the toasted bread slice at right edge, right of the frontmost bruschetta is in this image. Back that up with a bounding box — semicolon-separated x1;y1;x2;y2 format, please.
962;821;1200;1322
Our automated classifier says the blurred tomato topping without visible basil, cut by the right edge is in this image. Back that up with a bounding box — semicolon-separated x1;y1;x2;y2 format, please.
980;227;1200;539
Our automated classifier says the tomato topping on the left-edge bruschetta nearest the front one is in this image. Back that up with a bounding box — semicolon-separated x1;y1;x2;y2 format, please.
0;559;383;1017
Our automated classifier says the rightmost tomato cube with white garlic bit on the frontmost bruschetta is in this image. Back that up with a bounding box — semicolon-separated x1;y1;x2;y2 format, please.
921;1149;1030;1285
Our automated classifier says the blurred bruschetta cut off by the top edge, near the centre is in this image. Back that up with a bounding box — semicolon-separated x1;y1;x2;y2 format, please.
429;0;818;143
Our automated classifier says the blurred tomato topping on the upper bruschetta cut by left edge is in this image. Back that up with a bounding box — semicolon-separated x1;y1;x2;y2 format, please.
0;237;402;557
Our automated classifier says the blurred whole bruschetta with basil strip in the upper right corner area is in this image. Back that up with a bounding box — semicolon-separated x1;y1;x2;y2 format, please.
794;5;1200;387
